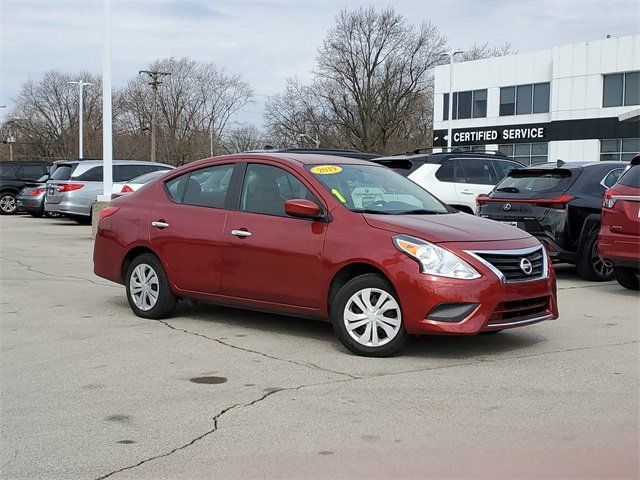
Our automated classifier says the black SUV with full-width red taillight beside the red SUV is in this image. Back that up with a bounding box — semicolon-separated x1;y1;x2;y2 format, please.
478;161;626;281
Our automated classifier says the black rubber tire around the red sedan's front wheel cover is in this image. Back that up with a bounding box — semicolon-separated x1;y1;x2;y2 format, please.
330;273;409;357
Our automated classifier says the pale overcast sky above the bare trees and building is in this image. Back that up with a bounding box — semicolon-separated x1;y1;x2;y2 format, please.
0;0;640;125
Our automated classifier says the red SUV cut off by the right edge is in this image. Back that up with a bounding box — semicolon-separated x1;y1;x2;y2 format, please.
598;155;640;290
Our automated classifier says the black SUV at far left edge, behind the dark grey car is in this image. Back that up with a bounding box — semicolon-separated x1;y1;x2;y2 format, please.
0;161;51;215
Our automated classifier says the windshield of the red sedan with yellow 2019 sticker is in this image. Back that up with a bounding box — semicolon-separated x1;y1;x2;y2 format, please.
309;164;449;215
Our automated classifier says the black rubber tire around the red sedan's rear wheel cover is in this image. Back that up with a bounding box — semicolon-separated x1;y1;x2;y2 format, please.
125;253;178;320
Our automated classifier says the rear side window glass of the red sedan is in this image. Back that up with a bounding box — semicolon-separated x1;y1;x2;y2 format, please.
165;164;233;208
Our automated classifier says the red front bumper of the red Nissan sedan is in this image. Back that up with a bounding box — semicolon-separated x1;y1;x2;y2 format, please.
394;239;558;335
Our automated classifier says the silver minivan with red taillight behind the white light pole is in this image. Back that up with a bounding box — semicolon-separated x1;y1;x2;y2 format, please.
44;160;172;224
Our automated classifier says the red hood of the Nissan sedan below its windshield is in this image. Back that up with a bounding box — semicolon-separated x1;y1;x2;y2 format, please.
363;213;530;243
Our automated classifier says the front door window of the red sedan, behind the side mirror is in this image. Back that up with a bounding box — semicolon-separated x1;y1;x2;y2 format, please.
240;163;321;216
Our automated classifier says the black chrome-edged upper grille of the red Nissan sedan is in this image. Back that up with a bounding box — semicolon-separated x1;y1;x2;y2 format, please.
469;246;546;282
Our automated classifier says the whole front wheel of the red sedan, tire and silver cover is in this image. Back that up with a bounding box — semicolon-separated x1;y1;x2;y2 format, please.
330;273;409;357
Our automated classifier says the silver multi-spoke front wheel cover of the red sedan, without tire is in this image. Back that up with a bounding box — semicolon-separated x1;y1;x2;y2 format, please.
343;288;402;347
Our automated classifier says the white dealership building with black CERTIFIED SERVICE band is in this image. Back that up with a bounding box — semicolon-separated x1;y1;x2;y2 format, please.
433;34;640;164
